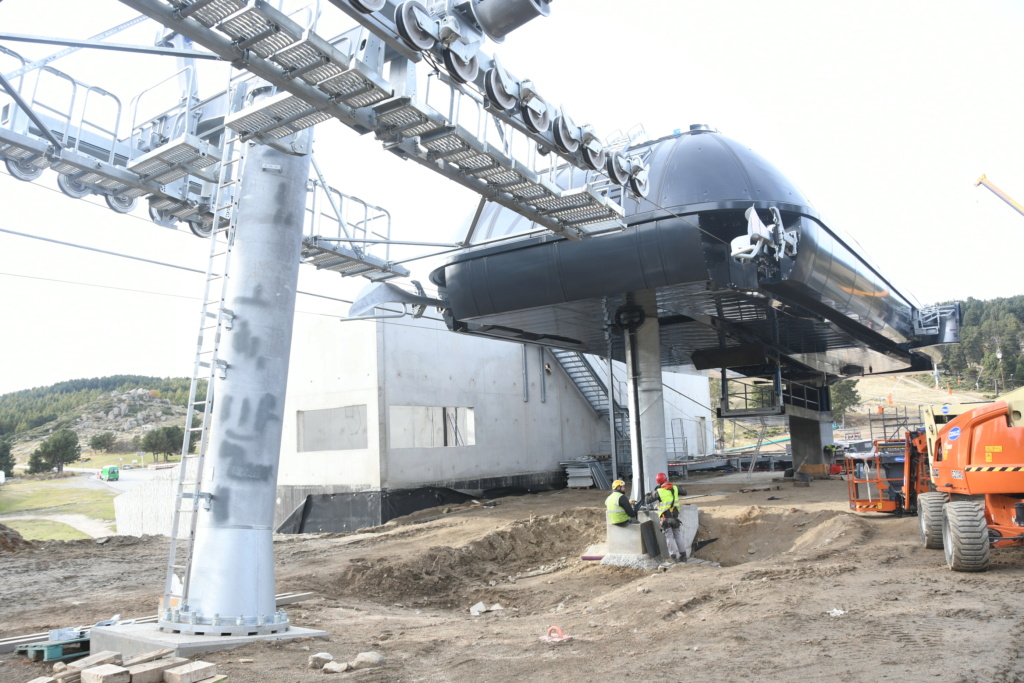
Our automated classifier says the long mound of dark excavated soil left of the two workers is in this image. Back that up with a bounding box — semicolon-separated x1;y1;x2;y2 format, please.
310;508;604;605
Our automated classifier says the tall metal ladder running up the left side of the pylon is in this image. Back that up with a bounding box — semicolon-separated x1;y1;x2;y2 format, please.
162;122;250;616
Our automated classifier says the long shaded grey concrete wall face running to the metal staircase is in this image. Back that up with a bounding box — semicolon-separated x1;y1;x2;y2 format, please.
381;321;608;488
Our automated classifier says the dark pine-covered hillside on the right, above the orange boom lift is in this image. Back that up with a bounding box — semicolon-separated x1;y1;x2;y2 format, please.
941;296;1024;393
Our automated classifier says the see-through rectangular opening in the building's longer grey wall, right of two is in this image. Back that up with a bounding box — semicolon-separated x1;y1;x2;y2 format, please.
389;405;476;449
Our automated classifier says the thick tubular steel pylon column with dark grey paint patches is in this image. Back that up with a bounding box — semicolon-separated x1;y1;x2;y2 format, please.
189;132;309;632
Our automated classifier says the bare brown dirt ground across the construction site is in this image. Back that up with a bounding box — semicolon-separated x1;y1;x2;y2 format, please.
0;475;1024;683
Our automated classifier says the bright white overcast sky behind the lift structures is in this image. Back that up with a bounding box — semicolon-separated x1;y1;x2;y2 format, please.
0;0;1024;393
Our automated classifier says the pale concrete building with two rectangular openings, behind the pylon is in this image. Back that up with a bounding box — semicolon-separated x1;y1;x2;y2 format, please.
115;316;713;533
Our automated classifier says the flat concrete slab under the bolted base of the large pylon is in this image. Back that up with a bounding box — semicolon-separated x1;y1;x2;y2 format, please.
89;624;327;657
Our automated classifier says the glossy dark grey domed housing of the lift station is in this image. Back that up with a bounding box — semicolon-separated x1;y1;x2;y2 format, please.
431;128;935;380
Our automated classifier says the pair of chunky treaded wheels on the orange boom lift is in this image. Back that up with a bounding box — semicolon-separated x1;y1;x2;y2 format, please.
918;492;991;571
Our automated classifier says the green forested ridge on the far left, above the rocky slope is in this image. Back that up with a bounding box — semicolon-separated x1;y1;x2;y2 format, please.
0;375;198;438
